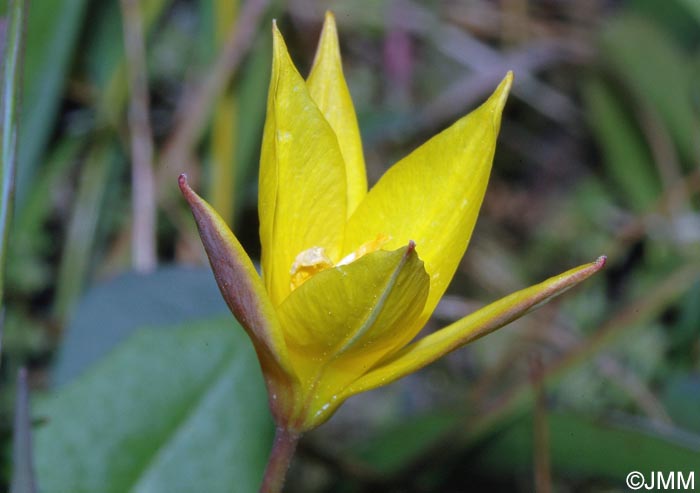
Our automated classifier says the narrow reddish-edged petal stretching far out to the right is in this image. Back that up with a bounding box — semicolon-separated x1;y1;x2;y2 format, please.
342;257;606;399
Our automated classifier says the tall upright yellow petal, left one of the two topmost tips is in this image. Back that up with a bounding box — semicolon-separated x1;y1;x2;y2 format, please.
258;26;347;306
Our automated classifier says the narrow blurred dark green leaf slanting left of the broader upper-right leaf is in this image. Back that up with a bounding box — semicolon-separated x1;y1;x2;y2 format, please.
583;78;661;211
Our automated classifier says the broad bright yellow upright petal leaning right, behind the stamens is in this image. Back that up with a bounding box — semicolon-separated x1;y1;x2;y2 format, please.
344;72;513;342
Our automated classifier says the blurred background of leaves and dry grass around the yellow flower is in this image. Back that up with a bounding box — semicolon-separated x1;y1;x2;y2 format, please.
0;0;700;493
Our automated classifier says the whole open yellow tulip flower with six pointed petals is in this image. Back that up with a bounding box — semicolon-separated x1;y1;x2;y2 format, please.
180;13;605;434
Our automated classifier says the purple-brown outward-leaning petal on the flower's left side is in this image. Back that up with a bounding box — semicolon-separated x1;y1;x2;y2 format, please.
179;175;293;375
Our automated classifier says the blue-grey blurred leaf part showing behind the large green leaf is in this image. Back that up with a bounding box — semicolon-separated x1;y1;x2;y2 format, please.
53;266;228;386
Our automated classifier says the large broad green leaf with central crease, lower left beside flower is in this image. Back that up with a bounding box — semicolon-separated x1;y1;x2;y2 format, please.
34;317;272;493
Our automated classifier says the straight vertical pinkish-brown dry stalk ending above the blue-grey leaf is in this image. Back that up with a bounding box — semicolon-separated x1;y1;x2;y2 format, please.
120;0;157;272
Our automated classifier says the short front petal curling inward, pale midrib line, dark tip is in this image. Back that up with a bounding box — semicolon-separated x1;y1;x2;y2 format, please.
278;244;429;426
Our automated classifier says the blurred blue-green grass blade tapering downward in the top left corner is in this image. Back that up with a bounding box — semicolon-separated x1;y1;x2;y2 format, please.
16;0;86;210
